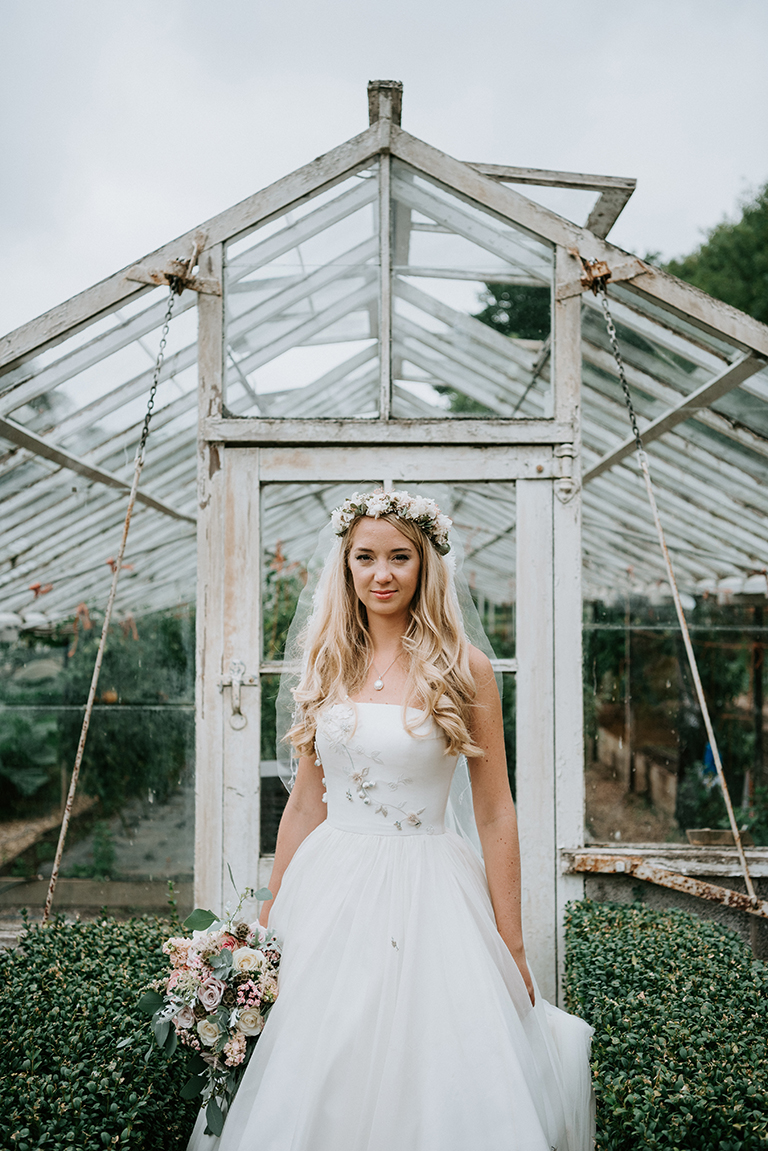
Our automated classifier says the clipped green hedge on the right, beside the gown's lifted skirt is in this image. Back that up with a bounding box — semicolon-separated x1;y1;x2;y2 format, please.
565;900;768;1151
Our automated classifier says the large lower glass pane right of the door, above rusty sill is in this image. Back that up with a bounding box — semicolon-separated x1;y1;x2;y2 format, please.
584;593;768;845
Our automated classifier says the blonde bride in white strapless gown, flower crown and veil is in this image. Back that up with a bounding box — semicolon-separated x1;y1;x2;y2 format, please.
189;491;594;1151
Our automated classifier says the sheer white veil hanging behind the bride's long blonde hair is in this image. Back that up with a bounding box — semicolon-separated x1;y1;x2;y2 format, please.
276;524;502;855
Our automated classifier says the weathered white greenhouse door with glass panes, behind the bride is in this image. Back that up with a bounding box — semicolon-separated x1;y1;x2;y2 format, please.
196;435;581;994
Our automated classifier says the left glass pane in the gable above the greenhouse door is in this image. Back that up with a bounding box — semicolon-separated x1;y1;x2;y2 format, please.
225;162;380;417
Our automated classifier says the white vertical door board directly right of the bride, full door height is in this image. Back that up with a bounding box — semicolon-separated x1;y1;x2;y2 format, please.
516;481;557;1000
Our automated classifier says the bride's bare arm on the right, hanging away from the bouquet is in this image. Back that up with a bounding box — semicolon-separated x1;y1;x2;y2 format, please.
469;648;534;1003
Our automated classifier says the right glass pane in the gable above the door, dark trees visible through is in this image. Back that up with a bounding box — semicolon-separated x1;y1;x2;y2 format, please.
391;161;554;418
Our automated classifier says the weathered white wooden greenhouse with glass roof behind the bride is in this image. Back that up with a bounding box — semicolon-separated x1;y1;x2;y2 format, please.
0;82;768;999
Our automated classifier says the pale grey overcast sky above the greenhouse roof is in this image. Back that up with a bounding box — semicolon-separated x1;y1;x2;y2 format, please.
0;0;768;333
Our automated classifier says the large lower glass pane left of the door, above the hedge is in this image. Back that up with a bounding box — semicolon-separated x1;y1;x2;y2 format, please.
0;601;195;893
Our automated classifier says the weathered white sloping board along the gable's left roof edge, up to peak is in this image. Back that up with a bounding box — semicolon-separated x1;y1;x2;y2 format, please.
0;120;389;373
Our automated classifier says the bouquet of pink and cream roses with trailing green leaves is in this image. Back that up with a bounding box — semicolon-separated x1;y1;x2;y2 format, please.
138;887;280;1135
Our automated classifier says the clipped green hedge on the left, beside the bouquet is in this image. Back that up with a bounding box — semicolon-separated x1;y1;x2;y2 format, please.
0;917;197;1151
